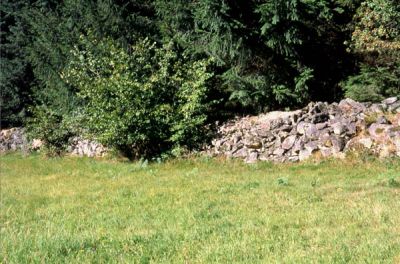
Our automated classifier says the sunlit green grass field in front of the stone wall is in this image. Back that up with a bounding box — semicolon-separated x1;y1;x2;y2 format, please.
0;155;400;263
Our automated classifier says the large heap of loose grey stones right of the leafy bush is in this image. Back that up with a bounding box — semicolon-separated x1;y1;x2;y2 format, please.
206;97;400;163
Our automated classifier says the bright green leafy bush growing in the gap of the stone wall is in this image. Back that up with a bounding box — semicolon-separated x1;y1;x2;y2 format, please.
62;36;212;156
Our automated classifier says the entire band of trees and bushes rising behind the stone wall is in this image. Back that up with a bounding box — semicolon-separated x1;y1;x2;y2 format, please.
0;0;400;157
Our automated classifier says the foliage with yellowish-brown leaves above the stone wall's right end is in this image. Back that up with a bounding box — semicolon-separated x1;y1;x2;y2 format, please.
342;0;400;101
